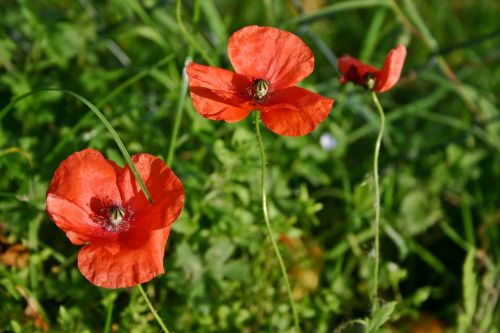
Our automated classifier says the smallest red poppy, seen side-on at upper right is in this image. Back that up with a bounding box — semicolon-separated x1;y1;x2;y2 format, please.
338;45;406;93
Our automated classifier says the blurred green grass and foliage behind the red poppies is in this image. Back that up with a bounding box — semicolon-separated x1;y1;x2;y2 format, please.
0;0;500;333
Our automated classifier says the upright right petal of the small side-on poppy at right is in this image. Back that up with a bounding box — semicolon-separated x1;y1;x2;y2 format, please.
375;45;406;93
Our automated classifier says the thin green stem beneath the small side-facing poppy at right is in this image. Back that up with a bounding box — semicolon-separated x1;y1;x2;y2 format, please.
371;92;385;311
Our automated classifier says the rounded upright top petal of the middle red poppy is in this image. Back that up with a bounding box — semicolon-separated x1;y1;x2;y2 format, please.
228;25;314;90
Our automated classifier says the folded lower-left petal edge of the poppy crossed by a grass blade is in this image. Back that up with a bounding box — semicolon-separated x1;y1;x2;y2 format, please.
47;194;119;253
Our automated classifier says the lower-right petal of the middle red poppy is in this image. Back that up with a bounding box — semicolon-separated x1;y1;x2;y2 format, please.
259;87;334;136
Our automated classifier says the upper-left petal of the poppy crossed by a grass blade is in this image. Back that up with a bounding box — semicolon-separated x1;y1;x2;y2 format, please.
47;149;121;243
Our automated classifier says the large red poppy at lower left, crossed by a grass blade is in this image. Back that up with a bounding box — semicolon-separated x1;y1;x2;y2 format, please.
47;149;184;288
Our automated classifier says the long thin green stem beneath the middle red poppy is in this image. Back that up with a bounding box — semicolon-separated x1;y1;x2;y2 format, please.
255;111;300;333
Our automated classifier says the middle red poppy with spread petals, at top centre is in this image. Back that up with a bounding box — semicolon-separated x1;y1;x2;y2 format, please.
187;26;333;136
